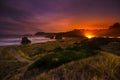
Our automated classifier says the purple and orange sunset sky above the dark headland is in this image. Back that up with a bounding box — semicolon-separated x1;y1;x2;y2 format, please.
0;0;120;34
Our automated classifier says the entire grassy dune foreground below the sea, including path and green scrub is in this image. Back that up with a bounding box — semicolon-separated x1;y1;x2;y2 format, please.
0;38;120;80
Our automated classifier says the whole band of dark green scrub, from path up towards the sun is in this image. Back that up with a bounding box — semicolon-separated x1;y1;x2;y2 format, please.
28;37;103;72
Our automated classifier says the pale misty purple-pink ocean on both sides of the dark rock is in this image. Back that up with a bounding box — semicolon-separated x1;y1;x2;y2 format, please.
0;36;54;46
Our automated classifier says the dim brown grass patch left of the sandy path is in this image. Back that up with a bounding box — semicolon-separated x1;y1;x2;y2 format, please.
0;47;26;80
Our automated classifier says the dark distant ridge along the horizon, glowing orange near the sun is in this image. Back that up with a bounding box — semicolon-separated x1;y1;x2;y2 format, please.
35;22;120;37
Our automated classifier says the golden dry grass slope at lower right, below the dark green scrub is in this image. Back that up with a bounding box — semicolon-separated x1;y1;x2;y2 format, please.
36;53;120;80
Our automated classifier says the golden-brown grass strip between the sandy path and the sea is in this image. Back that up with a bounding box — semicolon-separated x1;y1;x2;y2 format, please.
17;38;83;58
